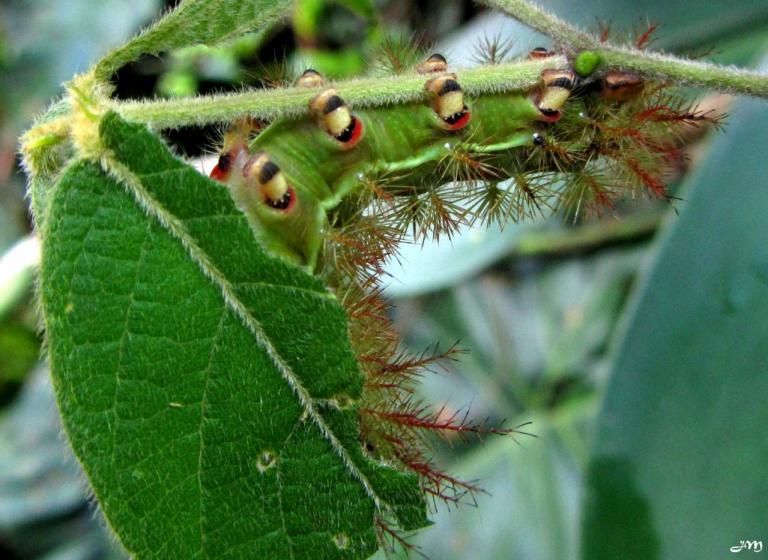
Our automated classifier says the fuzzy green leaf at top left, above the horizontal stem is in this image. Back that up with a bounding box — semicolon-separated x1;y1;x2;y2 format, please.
95;0;291;80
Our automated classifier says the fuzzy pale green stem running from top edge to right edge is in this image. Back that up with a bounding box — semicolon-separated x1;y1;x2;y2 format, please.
479;0;768;99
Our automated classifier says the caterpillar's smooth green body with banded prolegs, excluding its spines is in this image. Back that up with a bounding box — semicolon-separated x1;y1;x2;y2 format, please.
211;51;608;268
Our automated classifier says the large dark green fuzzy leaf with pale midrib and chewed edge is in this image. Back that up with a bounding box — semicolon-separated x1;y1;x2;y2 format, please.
41;114;428;558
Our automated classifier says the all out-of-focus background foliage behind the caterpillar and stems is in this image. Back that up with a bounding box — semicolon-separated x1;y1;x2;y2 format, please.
0;0;768;560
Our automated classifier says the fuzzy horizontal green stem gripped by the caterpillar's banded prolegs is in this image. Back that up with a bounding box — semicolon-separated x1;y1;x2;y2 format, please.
111;56;568;128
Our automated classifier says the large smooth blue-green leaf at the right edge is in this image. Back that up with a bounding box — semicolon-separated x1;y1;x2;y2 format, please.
583;86;768;560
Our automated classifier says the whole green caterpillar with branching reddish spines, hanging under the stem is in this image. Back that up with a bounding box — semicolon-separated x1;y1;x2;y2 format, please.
211;48;714;531
